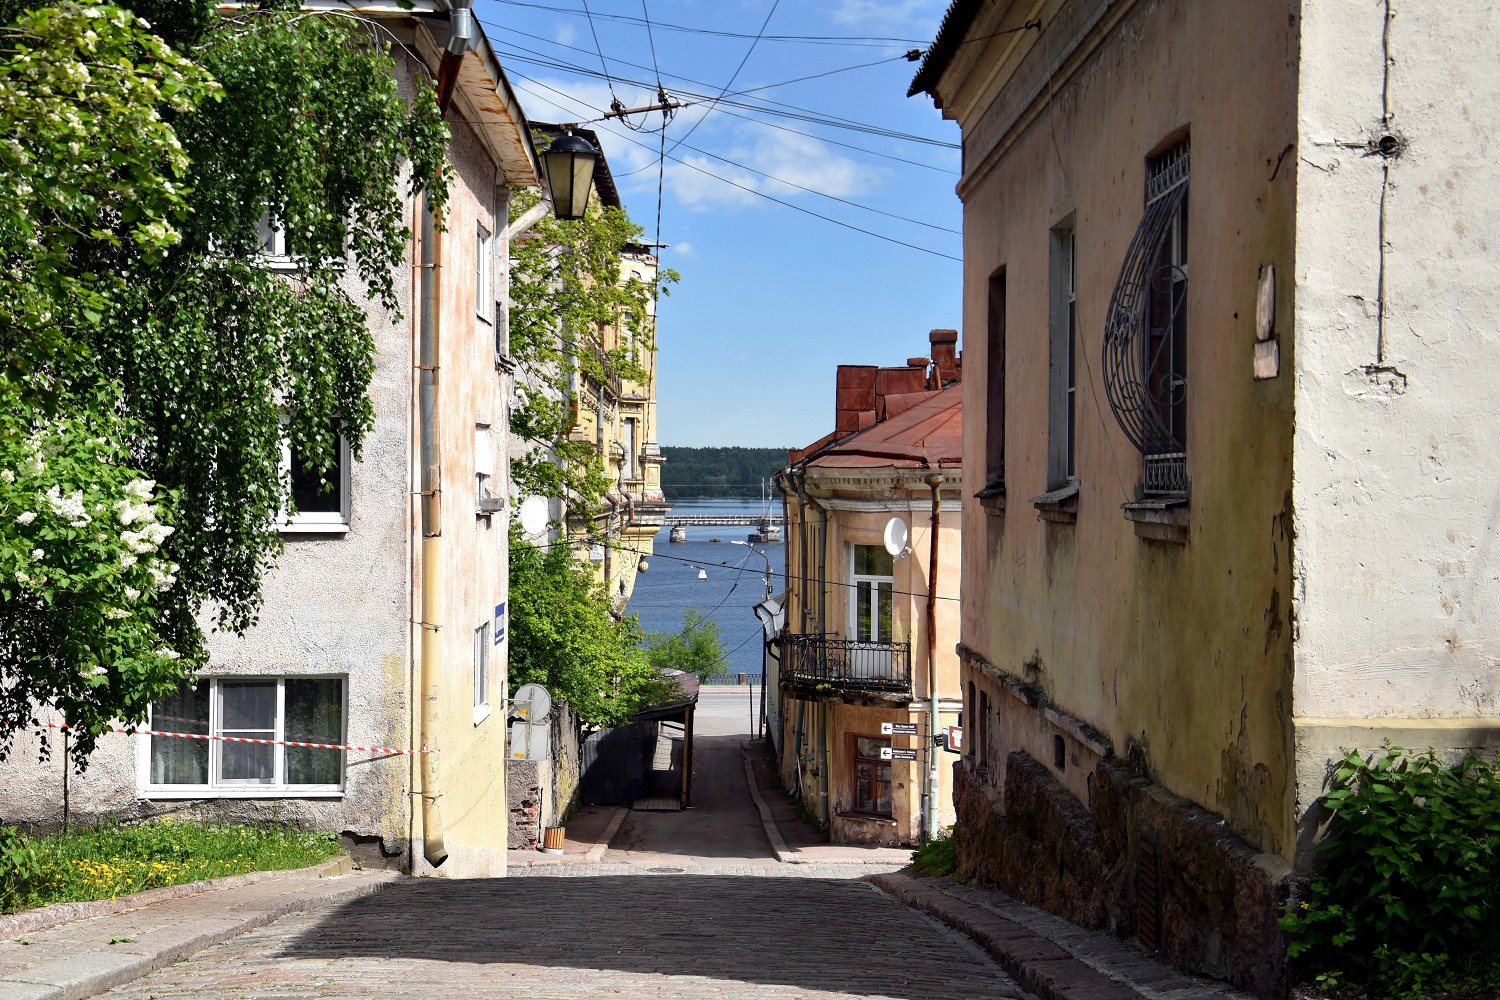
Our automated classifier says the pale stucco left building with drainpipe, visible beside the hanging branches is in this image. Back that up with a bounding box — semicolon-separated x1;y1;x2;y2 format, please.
0;13;539;876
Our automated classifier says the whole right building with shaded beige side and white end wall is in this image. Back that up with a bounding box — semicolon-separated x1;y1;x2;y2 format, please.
912;0;1500;996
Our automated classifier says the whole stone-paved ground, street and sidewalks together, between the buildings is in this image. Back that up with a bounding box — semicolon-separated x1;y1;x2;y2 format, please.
0;741;1239;1000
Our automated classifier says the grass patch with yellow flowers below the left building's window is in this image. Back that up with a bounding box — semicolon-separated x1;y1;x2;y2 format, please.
0;819;339;913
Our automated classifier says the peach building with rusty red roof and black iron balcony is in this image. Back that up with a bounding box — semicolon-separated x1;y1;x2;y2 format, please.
771;330;963;846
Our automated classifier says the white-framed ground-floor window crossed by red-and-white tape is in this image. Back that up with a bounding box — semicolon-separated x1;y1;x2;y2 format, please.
141;676;347;798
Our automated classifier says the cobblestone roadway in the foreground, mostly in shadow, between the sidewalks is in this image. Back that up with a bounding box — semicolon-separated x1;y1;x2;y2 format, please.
107;865;1026;1000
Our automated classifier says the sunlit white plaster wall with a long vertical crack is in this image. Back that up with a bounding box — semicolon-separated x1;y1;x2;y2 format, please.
1293;0;1500;857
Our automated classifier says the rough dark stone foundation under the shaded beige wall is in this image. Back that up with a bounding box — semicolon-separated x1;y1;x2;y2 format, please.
954;751;1292;997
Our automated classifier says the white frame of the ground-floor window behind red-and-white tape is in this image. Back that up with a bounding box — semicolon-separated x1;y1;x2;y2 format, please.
135;673;350;799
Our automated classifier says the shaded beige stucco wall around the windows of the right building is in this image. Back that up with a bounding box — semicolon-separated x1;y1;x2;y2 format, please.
945;0;1298;852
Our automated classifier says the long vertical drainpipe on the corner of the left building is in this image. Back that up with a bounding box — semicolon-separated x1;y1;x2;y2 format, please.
417;196;449;868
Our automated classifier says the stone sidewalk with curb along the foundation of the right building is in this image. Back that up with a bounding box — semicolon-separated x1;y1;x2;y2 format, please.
866;874;1248;1000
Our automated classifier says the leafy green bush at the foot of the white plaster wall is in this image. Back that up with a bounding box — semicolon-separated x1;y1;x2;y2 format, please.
1281;742;1500;997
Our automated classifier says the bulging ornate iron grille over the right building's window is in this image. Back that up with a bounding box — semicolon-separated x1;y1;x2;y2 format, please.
1103;141;1188;495
